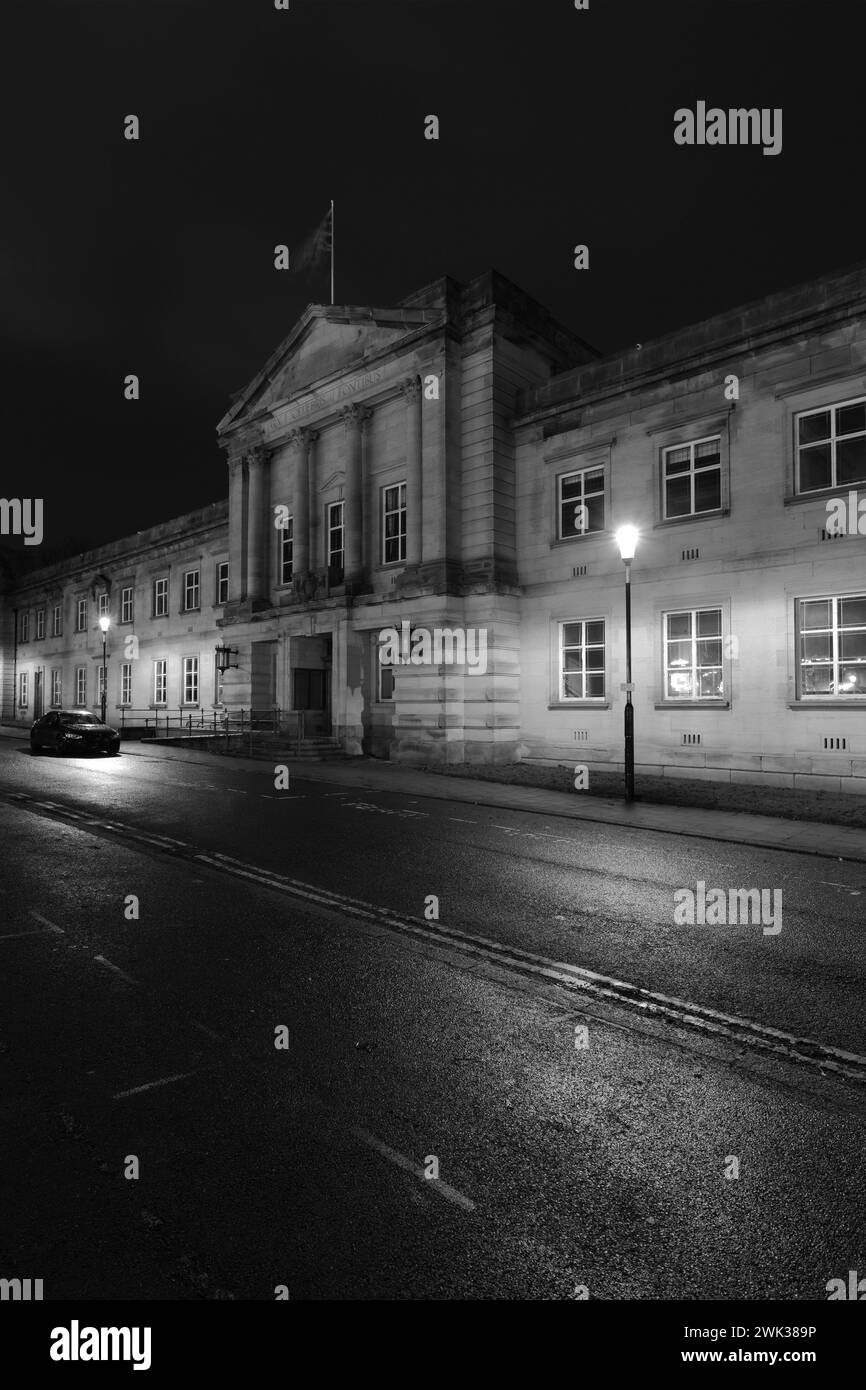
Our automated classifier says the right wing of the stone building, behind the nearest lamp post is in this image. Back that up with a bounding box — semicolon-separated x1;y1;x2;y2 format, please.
513;265;866;792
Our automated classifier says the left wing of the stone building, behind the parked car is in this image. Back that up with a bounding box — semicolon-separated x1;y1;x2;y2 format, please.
0;502;228;728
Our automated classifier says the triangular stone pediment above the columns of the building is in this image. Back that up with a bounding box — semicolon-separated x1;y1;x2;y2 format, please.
217;304;441;432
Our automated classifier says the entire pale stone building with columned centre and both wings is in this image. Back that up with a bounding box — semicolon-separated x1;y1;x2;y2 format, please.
0;264;866;791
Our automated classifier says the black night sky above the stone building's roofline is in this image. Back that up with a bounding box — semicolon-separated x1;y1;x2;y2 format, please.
0;0;866;563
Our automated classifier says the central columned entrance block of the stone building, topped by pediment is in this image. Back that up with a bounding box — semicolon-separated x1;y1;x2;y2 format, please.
218;274;594;762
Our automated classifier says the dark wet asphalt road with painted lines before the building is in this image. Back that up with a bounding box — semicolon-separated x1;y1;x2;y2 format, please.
0;742;866;1300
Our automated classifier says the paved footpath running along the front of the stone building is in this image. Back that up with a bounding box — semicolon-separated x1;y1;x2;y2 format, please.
0;724;866;863
